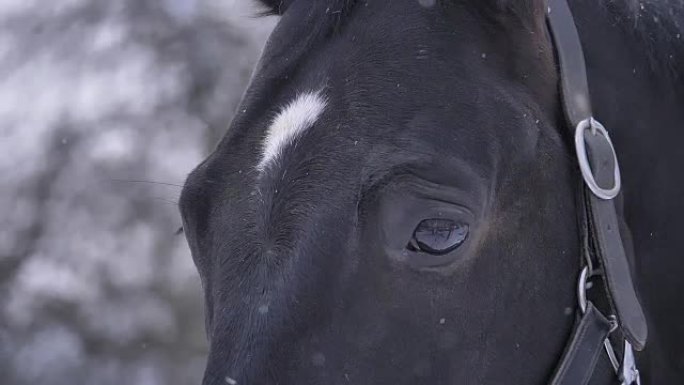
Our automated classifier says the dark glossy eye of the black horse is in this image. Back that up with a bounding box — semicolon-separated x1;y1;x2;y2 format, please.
407;218;468;255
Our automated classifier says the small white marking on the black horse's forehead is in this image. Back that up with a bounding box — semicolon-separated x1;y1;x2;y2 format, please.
257;92;326;171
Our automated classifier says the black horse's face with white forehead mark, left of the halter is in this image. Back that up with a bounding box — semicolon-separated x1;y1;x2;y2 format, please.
181;0;684;385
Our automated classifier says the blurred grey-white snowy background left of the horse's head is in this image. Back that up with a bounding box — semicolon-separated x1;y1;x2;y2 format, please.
0;0;276;385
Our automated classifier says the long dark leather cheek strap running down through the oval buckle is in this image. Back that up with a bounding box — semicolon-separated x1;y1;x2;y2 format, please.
547;0;648;350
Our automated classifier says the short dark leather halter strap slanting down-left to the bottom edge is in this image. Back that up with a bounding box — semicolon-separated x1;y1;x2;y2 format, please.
550;302;611;385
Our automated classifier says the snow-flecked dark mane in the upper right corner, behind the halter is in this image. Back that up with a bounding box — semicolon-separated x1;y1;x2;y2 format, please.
599;0;684;85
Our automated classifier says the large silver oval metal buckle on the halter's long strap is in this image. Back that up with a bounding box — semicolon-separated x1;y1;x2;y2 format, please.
575;118;622;200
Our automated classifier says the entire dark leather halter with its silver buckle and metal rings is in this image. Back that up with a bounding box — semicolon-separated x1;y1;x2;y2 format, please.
547;0;648;385
